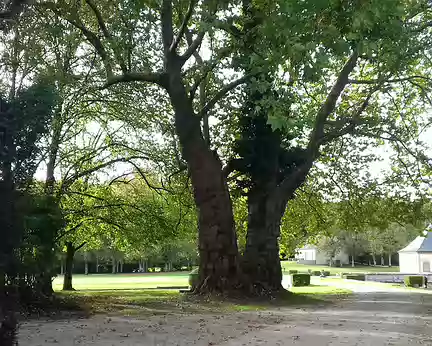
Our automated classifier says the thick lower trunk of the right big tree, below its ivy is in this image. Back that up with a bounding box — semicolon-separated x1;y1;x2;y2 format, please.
242;191;287;292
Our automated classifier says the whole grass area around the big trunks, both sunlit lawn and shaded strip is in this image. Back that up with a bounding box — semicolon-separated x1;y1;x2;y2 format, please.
53;272;351;315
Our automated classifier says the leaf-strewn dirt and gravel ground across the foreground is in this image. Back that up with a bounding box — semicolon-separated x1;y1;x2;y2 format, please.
20;292;432;346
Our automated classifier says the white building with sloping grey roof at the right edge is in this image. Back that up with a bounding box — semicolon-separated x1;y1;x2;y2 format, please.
399;231;432;274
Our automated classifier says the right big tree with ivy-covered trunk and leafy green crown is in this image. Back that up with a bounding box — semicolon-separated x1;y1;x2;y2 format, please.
224;1;431;290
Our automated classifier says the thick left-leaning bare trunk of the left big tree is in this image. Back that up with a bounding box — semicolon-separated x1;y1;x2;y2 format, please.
166;63;242;293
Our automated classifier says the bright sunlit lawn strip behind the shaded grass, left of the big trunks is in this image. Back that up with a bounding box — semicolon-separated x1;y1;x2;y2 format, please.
53;272;189;291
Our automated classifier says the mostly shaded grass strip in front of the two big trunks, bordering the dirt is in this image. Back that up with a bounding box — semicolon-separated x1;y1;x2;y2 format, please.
56;285;351;316
